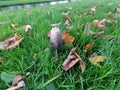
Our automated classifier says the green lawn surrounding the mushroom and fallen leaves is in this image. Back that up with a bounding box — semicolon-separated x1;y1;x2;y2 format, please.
0;0;120;90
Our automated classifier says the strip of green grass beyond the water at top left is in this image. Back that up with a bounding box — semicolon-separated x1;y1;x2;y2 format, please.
0;0;53;6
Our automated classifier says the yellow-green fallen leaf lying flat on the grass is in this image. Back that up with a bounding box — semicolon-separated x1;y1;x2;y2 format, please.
88;53;105;67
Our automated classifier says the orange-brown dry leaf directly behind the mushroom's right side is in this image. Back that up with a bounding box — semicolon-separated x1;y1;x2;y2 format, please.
62;30;75;45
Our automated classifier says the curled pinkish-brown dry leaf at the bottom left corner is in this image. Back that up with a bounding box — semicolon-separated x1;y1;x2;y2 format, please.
7;75;26;90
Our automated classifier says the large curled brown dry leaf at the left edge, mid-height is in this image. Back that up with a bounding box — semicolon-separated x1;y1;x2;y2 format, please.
0;33;23;49
